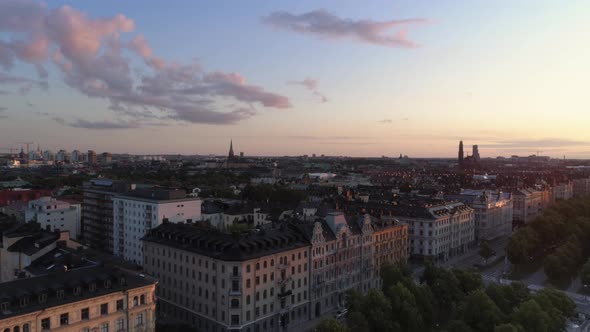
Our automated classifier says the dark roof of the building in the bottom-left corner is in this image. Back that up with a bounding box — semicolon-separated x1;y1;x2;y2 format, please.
0;266;156;320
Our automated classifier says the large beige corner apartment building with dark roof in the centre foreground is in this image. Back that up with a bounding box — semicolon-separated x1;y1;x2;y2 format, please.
144;223;310;332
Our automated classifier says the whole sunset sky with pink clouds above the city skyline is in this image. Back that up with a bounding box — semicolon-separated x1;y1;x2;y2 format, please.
0;0;590;158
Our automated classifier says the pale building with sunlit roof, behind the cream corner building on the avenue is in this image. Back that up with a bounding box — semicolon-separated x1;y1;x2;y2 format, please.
445;189;513;241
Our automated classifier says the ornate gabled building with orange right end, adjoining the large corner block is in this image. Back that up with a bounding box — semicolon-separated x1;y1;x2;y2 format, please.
308;212;408;319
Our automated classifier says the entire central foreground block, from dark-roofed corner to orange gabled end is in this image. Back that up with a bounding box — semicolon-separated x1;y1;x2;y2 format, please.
143;212;408;332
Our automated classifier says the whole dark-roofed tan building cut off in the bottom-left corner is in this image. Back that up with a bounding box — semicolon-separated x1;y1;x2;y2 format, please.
0;267;156;332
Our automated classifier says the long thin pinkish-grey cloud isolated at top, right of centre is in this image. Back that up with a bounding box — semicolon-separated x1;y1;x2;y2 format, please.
262;10;427;48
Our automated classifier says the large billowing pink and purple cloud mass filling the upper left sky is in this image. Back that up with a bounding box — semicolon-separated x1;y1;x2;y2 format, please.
0;0;291;125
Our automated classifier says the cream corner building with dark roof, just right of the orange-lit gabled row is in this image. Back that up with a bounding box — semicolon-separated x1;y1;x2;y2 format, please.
394;202;475;260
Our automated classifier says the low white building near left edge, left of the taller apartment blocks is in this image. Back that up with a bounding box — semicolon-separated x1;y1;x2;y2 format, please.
25;197;81;239
